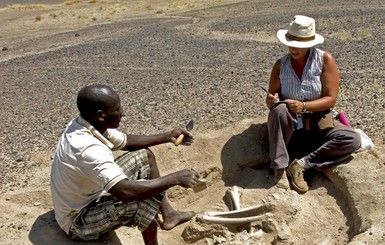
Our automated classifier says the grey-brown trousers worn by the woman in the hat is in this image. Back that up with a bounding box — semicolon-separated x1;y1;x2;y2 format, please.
267;103;361;169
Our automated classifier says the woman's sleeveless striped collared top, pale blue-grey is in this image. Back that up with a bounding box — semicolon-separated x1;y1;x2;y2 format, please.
279;48;324;101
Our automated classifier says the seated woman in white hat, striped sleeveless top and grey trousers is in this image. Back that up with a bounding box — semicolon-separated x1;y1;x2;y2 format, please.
266;15;361;193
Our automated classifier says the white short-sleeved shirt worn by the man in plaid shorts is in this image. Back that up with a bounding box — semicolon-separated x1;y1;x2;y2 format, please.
51;116;127;234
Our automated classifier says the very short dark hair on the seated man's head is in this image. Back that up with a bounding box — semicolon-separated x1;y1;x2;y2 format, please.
76;84;119;119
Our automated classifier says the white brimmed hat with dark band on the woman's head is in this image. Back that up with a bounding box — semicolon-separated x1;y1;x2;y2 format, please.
277;15;324;48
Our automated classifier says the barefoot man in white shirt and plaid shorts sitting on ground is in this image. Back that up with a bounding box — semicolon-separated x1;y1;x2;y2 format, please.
51;85;199;244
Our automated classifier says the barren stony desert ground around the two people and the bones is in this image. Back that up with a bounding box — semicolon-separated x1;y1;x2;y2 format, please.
0;0;385;245
